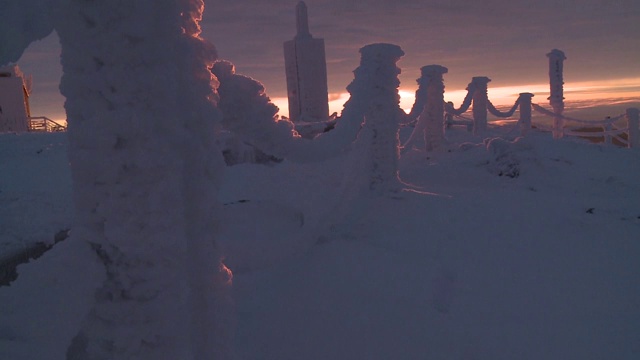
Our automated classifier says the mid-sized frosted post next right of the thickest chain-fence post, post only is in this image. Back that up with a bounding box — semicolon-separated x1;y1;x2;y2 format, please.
416;65;449;151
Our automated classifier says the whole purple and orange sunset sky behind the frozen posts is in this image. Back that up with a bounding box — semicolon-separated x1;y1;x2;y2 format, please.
12;0;640;119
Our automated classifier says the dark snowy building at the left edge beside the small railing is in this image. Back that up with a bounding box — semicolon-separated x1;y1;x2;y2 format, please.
0;65;31;133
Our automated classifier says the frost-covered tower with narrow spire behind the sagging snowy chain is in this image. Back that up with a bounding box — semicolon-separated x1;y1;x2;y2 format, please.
284;1;329;122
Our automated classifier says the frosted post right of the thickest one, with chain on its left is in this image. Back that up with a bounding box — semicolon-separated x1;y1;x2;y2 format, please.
403;65;449;151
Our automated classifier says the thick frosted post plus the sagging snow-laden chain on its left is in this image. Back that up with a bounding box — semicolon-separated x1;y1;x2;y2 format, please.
212;44;406;194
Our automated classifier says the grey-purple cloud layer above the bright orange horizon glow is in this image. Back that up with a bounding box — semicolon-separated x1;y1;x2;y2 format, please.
205;0;640;98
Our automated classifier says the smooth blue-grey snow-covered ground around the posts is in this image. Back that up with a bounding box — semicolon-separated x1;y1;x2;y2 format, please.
0;127;640;360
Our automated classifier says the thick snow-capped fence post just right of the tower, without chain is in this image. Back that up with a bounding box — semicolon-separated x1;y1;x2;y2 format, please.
347;44;404;195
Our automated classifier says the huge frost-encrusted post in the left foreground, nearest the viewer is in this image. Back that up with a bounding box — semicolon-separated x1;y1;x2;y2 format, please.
0;0;232;360
